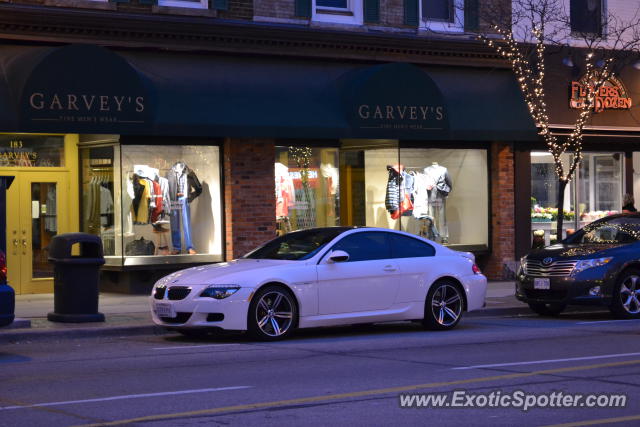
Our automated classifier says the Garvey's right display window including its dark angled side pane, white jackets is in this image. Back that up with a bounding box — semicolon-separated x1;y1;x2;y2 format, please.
340;140;489;250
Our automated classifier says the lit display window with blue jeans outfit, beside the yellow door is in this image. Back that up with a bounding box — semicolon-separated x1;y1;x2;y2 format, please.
80;144;223;265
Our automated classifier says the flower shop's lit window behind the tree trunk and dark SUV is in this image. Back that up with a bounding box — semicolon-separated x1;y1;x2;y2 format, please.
531;151;624;244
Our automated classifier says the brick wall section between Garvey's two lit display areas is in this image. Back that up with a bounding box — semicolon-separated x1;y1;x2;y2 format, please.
224;138;276;260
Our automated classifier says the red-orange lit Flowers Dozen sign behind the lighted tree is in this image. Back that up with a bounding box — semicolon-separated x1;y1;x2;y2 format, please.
569;77;631;113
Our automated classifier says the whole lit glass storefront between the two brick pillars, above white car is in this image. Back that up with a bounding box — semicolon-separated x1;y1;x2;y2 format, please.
275;139;489;251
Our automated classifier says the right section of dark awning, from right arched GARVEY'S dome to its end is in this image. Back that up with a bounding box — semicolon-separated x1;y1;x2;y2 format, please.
338;63;537;141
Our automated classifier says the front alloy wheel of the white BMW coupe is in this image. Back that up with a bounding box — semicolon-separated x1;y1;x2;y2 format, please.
248;286;297;340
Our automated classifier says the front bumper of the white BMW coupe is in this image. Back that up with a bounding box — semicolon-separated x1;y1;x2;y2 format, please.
149;288;253;331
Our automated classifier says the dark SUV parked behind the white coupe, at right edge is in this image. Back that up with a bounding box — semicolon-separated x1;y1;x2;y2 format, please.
516;214;640;319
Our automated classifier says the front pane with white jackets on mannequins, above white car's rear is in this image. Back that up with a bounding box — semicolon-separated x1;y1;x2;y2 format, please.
392;148;489;249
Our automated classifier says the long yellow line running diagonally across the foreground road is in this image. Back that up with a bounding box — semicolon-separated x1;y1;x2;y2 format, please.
78;360;640;427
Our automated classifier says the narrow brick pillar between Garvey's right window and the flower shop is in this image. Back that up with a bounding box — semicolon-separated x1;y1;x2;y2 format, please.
478;142;515;280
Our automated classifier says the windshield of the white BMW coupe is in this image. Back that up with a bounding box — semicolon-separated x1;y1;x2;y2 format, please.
244;227;351;261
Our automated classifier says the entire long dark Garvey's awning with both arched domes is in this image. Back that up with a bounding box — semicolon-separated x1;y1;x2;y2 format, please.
0;45;537;141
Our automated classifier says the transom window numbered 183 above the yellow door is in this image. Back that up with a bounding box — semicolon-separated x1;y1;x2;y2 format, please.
0;134;65;167
